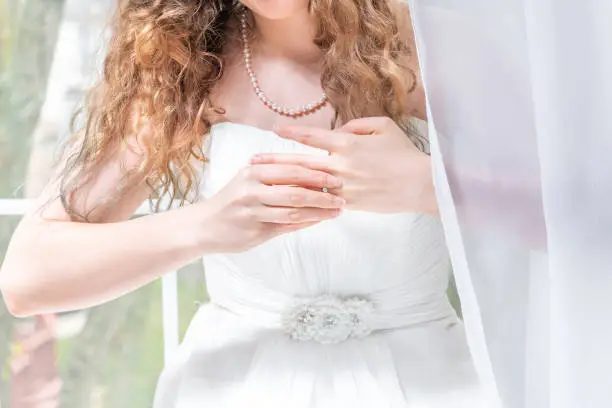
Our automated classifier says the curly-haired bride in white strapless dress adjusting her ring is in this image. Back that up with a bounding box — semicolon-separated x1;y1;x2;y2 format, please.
0;0;490;408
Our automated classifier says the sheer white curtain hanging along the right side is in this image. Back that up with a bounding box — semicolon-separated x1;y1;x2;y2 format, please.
410;0;612;408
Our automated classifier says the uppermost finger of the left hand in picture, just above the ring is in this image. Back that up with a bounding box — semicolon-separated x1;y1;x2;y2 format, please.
249;164;342;189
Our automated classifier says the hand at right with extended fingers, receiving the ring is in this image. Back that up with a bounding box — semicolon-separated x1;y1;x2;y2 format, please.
252;118;437;214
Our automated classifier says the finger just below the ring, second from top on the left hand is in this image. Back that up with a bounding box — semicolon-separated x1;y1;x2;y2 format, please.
259;186;344;209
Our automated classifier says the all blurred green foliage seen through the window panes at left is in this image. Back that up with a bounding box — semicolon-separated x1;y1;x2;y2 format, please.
0;0;206;408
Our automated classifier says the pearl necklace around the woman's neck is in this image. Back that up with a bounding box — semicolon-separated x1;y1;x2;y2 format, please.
240;12;328;119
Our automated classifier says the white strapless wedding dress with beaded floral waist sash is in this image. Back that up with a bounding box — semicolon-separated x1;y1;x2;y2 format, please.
154;123;492;408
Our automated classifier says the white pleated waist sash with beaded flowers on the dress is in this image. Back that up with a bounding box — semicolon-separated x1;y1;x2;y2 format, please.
211;286;457;344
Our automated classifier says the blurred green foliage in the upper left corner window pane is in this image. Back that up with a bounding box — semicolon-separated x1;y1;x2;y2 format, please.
0;0;63;198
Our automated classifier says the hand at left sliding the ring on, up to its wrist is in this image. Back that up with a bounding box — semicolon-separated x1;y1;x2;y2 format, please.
202;164;344;253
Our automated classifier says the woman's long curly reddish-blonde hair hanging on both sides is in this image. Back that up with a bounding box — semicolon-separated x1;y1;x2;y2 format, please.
60;0;420;220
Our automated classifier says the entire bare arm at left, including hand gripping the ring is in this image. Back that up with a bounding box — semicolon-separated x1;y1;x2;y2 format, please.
0;130;343;316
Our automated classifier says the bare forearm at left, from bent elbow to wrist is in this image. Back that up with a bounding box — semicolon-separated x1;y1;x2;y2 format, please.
0;205;206;316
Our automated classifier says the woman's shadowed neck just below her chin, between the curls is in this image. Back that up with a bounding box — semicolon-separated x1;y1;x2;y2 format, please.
254;10;323;64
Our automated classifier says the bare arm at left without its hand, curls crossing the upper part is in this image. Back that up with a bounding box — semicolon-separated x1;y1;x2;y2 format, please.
0;135;212;316
